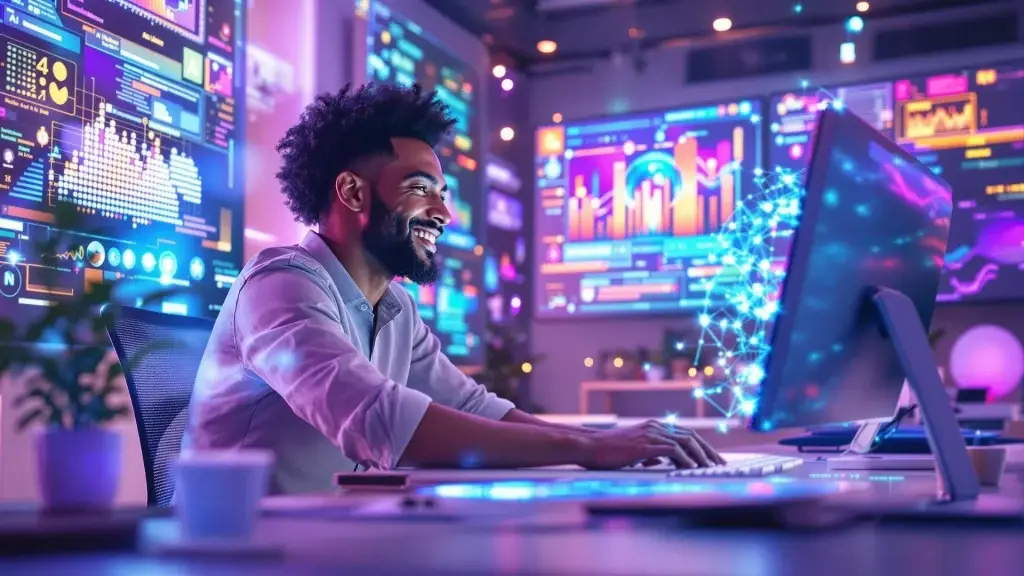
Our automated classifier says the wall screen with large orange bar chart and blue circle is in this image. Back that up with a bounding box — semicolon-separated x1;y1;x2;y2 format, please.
535;100;762;318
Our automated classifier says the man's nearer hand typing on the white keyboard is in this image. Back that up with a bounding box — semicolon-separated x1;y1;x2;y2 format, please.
575;420;725;470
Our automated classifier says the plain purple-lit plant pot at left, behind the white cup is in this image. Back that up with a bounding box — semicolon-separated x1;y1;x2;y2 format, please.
36;428;123;510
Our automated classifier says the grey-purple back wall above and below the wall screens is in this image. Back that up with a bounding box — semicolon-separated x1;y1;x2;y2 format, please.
528;3;1024;416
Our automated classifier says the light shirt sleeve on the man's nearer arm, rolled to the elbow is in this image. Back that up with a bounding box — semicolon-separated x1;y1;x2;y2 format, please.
233;260;431;469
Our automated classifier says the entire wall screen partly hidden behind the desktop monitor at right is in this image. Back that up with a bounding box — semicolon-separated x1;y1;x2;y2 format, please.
768;64;1024;301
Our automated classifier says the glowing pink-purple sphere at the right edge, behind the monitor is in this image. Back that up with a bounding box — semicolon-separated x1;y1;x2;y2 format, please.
949;324;1024;398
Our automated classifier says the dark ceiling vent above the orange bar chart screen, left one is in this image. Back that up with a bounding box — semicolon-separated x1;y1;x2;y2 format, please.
686;36;811;83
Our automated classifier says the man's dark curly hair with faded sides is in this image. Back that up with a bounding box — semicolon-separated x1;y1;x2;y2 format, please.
278;83;456;225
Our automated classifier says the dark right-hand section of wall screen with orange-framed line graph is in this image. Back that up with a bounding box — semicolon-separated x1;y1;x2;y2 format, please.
893;64;1024;301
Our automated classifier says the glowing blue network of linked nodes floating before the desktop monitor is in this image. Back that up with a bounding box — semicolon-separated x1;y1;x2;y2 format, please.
694;167;804;417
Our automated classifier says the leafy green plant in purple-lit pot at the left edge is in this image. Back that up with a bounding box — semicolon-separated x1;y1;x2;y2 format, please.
0;204;166;510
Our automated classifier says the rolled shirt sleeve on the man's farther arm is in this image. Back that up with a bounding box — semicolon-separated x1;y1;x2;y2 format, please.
406;293;515;420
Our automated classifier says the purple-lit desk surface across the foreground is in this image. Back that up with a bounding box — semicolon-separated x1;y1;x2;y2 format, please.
0;446;1024;576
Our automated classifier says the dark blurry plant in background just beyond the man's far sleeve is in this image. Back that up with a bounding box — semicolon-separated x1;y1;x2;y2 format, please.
476;323;544;413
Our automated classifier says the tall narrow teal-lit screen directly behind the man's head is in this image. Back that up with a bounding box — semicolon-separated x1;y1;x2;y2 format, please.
367;2;486;366
